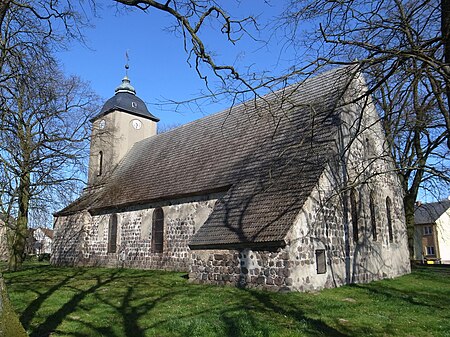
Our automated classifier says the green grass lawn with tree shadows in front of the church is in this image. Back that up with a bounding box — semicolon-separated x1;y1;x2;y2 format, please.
4;263;450;337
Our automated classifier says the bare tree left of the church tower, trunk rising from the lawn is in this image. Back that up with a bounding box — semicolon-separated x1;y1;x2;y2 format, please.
0;54;97;270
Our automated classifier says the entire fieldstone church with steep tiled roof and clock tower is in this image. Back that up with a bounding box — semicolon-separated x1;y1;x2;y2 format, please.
52;67;410;291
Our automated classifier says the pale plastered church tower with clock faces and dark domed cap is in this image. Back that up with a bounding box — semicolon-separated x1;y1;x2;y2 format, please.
88;76;159;187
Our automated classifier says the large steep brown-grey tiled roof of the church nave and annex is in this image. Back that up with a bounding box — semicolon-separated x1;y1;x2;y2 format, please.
57;68;358;248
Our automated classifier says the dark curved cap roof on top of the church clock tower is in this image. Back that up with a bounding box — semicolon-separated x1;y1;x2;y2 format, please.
91;76;159;122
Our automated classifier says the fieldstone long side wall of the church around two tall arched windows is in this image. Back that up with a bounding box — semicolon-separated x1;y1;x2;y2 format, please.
52;195;219;271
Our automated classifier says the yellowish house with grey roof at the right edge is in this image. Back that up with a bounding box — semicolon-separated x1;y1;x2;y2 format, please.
414;200;450;263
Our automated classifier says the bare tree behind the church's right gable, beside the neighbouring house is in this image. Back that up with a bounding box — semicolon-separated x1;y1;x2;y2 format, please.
373;64;450;259
